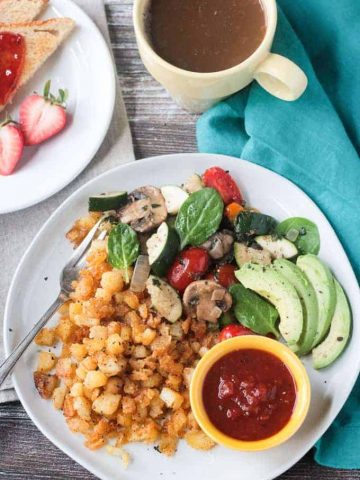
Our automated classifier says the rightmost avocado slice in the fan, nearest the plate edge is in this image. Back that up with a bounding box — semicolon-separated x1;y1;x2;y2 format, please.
312;280;351;369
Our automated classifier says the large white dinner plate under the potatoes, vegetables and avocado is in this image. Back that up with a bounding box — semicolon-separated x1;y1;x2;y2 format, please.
4;154;360;480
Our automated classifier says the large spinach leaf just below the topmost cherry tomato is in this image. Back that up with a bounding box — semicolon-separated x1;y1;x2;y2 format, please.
175;188;224;249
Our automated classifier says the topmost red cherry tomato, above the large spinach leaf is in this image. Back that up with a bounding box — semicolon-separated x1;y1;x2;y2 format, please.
203;167;243;205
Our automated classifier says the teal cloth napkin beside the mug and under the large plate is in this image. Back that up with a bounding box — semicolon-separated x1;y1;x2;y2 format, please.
197;0;360;469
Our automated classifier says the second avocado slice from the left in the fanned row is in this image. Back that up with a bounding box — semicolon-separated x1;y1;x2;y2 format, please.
273;258;318;355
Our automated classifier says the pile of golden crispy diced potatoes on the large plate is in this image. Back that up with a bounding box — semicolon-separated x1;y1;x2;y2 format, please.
34;216;218;464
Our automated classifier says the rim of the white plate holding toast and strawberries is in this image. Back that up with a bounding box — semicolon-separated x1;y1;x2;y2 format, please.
0;0;117;215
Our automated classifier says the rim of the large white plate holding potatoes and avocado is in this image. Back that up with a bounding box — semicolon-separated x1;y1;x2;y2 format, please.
3;152;360;480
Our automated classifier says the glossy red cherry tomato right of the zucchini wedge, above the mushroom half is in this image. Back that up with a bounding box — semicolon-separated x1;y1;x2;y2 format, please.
167;247;210;292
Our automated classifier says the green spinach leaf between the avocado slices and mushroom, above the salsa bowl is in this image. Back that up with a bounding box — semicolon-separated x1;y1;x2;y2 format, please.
229;283;279;338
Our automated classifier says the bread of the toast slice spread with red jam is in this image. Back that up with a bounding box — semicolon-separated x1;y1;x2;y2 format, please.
0;18;75;112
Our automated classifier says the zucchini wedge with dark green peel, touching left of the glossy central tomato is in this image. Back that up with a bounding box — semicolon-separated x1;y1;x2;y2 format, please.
146;222;180;277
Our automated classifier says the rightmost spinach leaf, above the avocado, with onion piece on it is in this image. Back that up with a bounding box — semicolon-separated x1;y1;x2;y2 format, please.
276;217;320;255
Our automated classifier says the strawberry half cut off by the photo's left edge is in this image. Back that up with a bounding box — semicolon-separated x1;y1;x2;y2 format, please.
0;117;24;175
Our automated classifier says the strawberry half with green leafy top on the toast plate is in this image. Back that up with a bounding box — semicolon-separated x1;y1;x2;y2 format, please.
19;80;68;145
